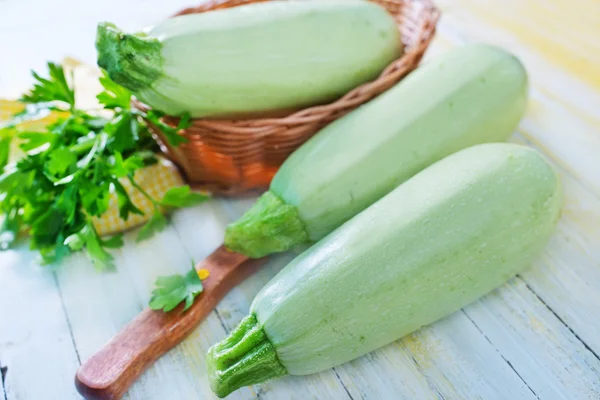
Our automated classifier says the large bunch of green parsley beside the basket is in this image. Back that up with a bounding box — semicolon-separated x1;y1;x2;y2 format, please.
0;63;206;270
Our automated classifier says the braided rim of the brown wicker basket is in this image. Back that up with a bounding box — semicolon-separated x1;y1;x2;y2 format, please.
132;0;441;129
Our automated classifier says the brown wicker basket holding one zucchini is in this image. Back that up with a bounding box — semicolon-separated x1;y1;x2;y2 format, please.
141;0;439;195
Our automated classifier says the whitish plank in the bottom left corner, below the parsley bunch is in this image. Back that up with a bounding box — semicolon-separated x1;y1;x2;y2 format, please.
0;247;79;400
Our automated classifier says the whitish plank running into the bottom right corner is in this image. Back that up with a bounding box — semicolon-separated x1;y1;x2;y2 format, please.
465;278;600;399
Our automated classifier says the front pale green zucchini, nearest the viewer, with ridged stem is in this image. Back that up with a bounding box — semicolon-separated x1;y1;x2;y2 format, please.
208;143;562;397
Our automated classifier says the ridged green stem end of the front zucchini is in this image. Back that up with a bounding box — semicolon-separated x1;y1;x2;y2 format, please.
207;315;287;398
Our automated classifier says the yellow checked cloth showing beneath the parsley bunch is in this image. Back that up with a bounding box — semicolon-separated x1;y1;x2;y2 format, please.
0;59;184;236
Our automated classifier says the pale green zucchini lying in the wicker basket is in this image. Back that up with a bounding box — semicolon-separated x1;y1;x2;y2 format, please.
96;0;402;117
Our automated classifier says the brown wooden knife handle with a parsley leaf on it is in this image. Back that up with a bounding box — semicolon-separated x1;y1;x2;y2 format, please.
75;246;264;400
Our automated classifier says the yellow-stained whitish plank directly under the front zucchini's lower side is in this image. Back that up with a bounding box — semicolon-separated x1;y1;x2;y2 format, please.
336;312;535;399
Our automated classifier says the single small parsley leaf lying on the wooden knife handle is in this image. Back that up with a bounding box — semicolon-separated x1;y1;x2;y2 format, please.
149;262;203;312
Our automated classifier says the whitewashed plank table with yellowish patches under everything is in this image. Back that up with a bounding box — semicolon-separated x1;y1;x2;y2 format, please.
0;0;600;400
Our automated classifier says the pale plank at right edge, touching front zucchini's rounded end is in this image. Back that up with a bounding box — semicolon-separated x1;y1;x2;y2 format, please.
521;136;600;357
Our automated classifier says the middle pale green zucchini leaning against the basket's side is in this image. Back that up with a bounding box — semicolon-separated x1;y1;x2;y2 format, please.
225;44;527;257
